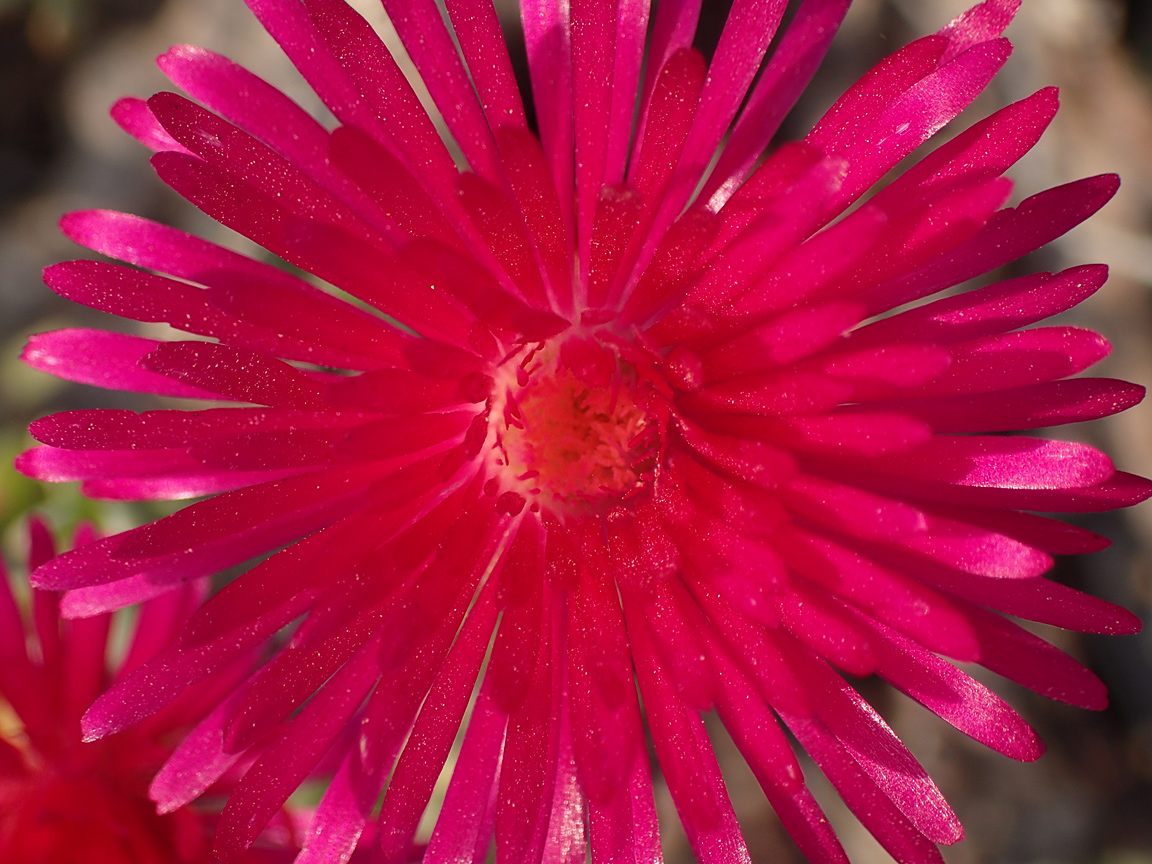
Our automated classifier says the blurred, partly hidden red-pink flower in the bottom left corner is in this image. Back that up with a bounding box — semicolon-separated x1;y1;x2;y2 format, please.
0;521;294;864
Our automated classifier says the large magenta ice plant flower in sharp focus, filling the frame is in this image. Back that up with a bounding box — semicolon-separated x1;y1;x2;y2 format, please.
20;0;1152;863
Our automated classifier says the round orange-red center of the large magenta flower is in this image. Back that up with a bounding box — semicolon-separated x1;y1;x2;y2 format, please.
502;338;655;513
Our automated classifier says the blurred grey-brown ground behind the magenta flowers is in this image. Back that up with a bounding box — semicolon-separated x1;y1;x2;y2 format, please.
0;0;1152;864
